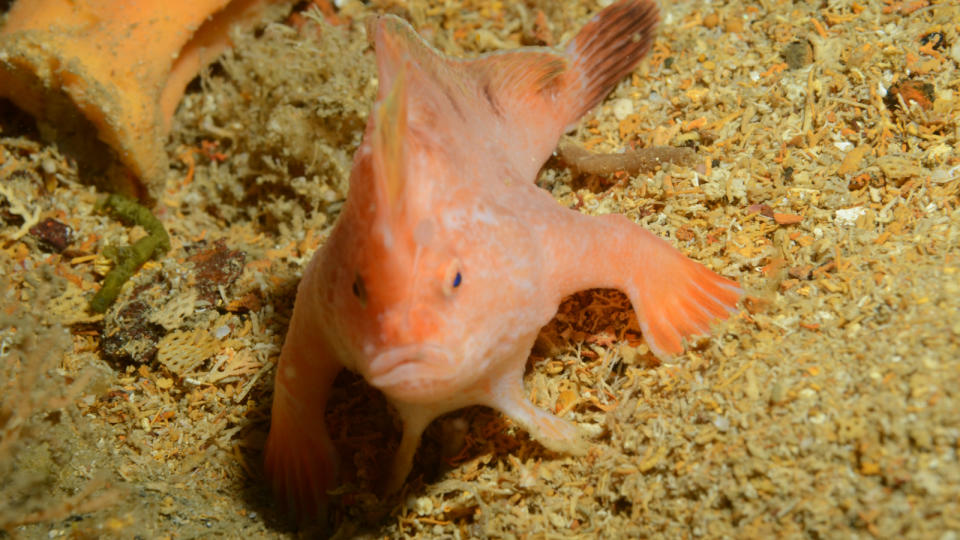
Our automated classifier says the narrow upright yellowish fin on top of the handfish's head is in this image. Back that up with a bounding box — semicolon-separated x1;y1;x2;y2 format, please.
371;63;407;209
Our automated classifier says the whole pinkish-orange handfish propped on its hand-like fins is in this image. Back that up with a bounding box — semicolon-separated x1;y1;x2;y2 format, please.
265;0;742;516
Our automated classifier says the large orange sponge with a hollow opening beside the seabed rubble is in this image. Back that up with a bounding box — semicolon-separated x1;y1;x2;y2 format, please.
0;0;293;201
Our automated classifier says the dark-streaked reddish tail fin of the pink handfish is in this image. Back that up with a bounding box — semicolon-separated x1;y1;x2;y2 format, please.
566;0;660;123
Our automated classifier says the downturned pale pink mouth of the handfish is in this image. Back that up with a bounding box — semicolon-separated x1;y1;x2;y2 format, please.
366;343;456;401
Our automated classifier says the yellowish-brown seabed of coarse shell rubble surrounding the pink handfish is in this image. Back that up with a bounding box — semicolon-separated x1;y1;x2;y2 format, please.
0;0;960;540
